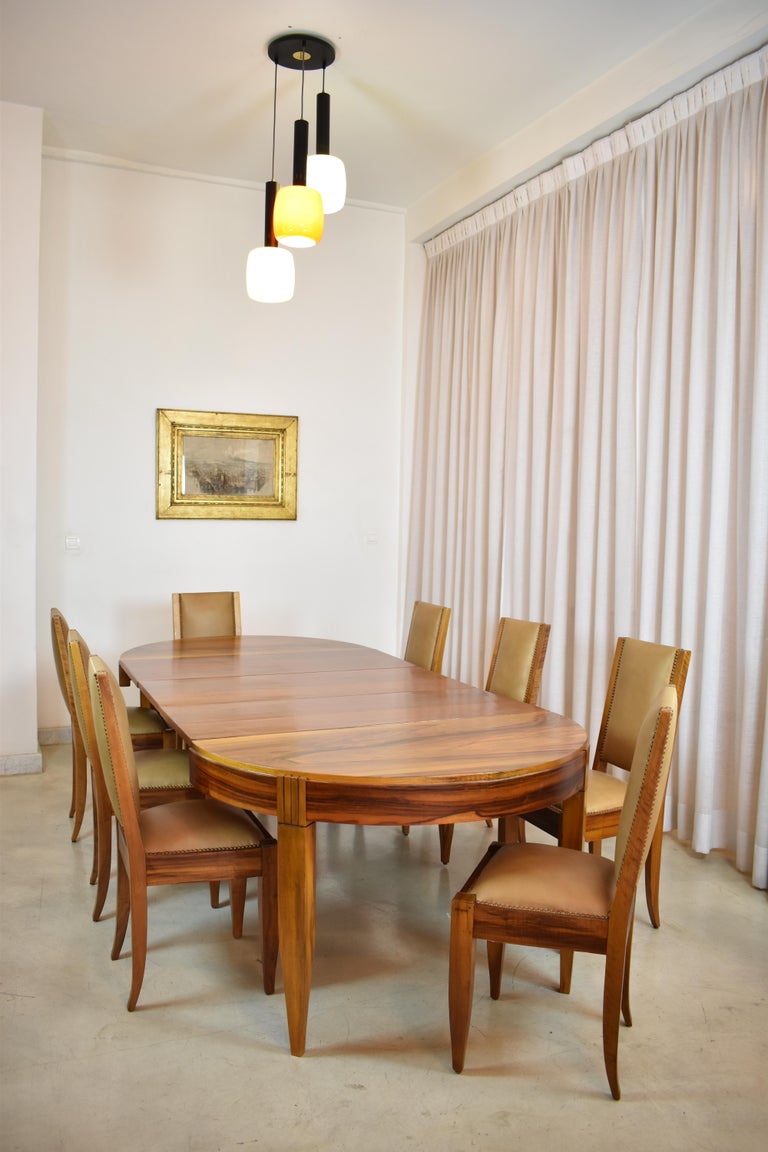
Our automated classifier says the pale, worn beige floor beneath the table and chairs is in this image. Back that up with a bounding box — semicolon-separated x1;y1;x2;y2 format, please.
0;746;768;1152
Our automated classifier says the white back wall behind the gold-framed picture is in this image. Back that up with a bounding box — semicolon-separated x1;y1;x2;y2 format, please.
38;159;404;729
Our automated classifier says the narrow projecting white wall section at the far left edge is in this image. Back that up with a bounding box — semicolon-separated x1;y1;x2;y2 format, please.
0;104;43;773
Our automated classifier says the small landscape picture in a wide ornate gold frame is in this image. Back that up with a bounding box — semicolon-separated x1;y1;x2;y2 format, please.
157;408;298;520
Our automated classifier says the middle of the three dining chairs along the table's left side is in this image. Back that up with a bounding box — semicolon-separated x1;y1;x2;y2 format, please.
67;629;206;920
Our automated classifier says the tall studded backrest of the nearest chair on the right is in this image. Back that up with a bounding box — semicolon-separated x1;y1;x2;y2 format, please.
614;684;679;899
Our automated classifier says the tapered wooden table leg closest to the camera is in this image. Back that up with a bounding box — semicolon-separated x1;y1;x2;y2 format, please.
277;776;317;1056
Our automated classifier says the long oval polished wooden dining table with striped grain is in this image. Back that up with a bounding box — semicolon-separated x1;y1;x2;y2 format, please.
120;636;587;1055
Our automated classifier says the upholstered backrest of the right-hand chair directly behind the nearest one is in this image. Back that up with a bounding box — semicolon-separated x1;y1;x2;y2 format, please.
592;636;691;772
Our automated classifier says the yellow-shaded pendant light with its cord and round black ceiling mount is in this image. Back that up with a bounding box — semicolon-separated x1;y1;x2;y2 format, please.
268;32;336;248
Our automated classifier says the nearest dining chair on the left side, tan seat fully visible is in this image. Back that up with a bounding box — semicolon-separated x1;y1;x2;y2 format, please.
89;655;277;1011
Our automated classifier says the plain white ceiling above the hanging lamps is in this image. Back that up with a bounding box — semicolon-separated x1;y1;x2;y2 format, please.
0;0;768;229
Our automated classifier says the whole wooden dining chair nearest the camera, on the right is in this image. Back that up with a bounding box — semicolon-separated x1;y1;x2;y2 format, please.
448;684;678;1100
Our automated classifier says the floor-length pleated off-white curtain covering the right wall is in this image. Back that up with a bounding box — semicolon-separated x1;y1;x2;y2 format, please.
406;48;768;887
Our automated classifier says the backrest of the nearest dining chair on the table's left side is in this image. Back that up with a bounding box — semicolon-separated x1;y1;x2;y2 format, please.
88;655;140;834
